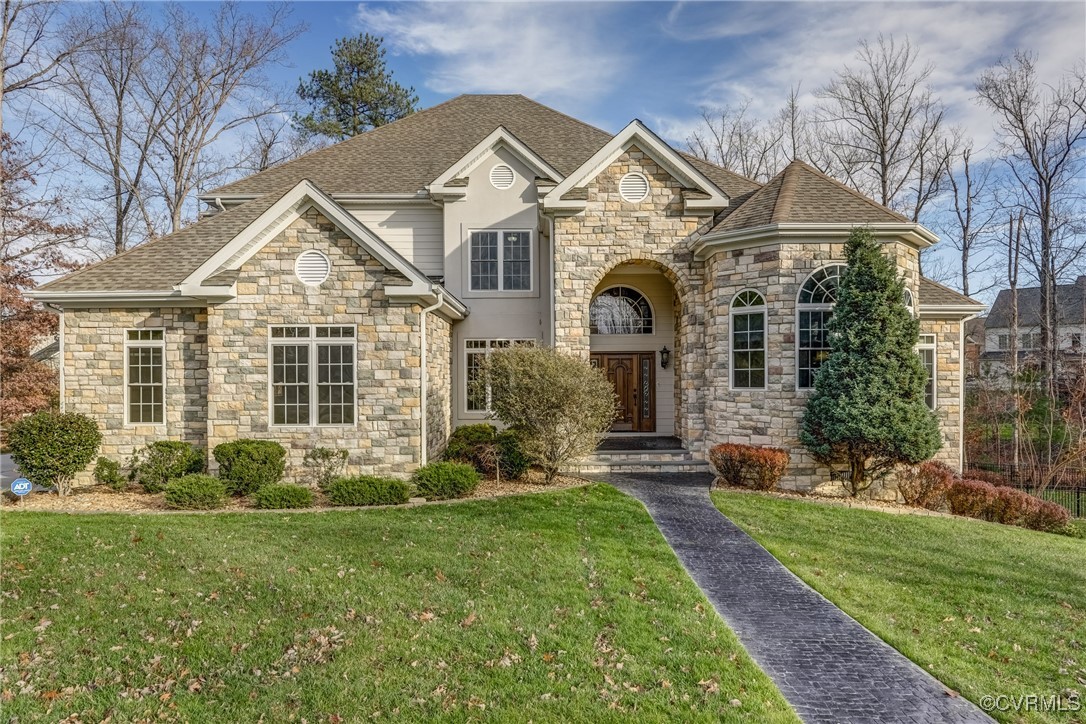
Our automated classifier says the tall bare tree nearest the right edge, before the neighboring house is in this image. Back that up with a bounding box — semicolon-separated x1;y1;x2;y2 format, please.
976;51;1086;394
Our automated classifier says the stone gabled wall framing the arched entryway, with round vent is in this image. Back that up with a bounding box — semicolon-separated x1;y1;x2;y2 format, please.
555;147;712;450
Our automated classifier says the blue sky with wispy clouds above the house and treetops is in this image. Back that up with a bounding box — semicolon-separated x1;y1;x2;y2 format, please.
248;1;1086;151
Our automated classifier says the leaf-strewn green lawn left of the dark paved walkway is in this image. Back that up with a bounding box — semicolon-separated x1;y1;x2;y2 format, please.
0;485;796;722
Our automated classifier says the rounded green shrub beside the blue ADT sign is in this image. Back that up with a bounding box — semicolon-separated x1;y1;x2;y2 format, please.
8;411;102;495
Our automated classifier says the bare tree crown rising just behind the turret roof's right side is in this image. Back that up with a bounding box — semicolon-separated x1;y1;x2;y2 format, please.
816;36;947;221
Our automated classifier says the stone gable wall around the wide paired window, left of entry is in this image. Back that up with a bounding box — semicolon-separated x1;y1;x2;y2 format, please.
207;209;421;479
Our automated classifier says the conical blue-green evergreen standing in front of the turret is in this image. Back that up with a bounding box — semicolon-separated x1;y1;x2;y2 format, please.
799;228;940;496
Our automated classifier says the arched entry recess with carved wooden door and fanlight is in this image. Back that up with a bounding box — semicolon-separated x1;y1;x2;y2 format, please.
589;262;681;436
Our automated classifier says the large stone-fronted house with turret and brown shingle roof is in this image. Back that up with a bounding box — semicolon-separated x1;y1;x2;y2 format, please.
35;96;982;487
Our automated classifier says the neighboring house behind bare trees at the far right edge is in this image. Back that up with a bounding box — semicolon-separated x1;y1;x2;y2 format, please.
980;275;1086;380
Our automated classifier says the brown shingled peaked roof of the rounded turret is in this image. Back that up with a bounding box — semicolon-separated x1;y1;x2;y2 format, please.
712;160;908;232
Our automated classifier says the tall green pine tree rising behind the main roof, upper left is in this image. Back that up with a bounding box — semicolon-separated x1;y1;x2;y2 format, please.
294;33;418;141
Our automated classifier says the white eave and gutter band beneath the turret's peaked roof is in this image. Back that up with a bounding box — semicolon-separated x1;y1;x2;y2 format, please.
694;221;938;258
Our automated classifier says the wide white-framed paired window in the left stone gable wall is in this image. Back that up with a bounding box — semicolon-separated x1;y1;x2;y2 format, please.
270;325;357;425
